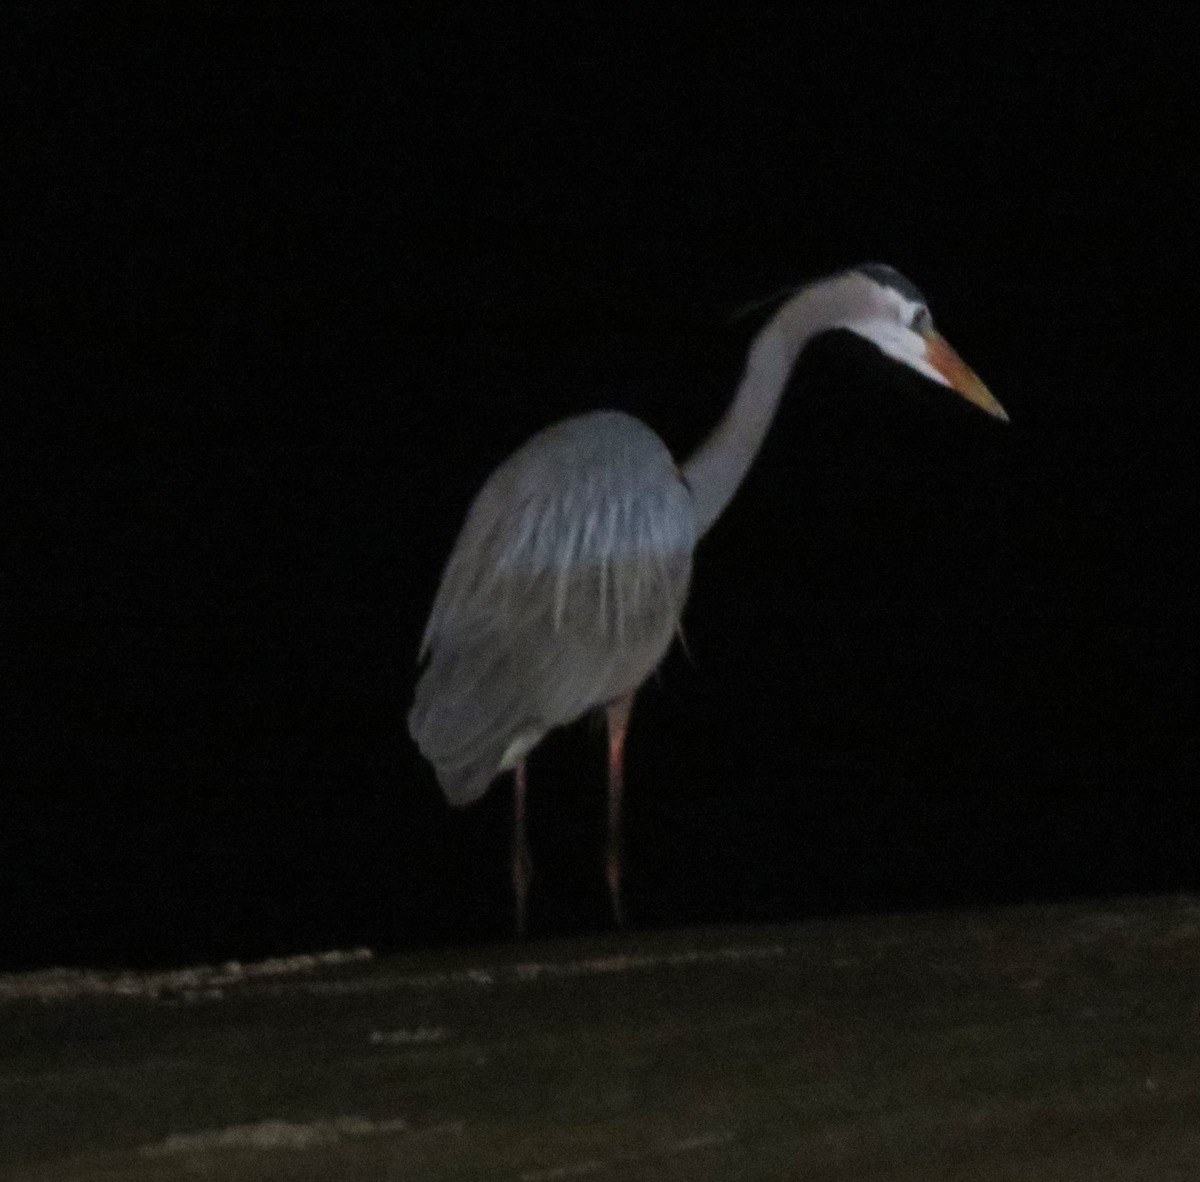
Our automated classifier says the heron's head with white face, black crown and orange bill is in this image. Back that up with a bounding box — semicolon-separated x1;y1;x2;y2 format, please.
839;263;1008;422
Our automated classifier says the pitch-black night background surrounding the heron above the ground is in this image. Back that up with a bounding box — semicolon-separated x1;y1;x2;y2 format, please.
0;0;1200;966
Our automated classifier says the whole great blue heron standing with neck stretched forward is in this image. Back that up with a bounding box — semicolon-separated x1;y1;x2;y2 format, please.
408;263;1007;935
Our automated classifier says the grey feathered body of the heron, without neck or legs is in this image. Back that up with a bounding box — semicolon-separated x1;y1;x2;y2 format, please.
409;412;696;803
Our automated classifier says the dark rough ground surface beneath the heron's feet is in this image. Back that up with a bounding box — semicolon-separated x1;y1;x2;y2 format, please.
0;899;1200;1182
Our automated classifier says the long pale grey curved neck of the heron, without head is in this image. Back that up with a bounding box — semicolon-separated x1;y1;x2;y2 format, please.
683;276;863;534
